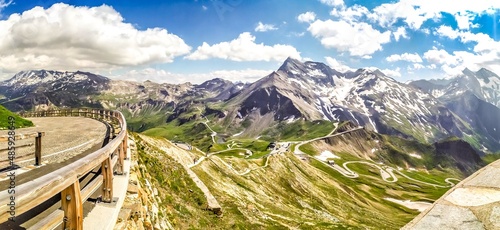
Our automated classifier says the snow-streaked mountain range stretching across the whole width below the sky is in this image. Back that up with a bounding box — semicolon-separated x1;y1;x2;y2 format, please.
0;58;500;153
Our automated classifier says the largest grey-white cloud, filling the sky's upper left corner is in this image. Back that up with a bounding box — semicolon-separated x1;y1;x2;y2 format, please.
0;3;191;72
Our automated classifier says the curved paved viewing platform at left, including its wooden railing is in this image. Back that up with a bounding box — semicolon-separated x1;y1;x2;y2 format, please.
0;108;130;229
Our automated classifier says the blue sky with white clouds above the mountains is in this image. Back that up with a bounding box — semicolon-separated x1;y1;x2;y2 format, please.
0;0;500;84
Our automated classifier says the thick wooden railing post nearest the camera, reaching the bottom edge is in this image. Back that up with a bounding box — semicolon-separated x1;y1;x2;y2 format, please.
61;179;83;230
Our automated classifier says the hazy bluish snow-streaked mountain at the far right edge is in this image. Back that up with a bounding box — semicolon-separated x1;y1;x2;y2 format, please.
410;68;500;151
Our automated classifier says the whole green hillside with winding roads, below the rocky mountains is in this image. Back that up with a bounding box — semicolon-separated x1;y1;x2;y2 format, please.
123;123;479;229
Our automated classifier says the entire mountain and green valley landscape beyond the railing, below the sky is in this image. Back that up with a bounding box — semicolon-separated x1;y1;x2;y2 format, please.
0;58;500;229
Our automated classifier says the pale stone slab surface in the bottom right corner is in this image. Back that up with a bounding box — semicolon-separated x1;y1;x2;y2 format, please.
402;160;500;230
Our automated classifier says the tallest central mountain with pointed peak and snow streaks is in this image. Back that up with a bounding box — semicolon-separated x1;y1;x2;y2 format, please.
229;58;470;144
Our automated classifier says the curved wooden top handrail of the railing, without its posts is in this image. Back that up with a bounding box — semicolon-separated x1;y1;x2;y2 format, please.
0;109;128;228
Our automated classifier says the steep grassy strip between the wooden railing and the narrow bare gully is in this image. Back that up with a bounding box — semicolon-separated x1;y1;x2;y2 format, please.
134;135;223;229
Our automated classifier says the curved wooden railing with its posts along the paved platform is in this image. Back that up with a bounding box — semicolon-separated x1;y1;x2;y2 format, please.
0;109;128;229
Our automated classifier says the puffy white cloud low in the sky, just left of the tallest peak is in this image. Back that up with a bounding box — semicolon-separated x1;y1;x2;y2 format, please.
185;32;300;61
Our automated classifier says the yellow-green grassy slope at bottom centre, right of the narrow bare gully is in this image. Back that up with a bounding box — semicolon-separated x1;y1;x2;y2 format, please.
194;150;447;229
